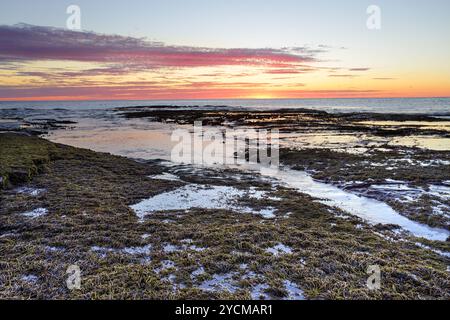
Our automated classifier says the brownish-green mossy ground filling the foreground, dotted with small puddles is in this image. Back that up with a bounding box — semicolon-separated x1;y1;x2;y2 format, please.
0;134;450;299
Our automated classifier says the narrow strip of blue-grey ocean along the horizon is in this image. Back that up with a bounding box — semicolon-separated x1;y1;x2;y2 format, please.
0;98;450;115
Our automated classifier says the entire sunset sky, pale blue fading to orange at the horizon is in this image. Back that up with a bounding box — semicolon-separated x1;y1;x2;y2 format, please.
0;0;450;100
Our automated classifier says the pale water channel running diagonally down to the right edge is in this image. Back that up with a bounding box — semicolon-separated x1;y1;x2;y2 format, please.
261;169;450;241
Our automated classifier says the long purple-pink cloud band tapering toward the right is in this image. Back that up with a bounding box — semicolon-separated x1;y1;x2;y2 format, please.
0;24;317;72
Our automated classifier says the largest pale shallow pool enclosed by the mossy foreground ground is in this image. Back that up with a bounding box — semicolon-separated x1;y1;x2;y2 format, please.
131;184;275;220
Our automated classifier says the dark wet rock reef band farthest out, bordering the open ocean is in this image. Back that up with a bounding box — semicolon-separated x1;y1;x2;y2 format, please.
115;106;450;137
